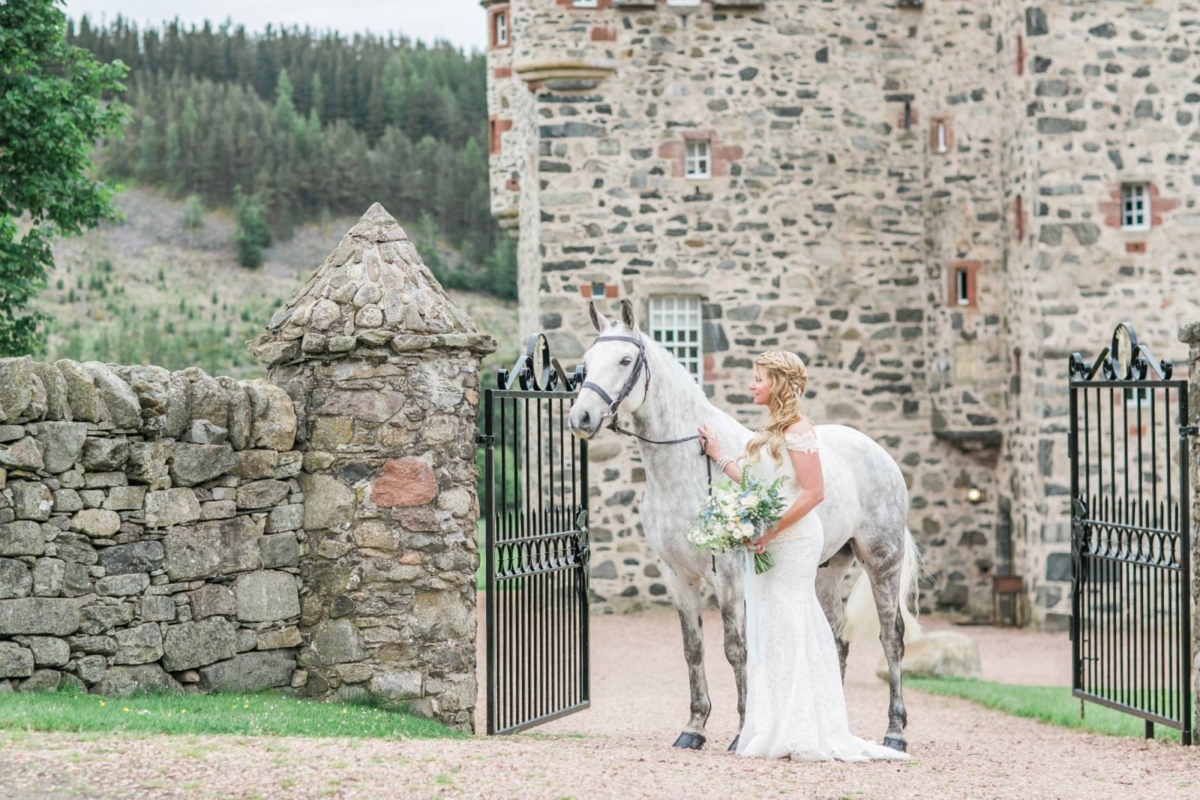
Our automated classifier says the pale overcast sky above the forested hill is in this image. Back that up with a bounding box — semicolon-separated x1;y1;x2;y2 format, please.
65;0;487;50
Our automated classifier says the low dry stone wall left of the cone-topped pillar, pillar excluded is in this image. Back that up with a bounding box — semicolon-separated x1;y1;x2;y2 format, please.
0;357;305;694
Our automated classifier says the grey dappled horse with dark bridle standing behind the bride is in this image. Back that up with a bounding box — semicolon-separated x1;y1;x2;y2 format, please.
569;301;920;751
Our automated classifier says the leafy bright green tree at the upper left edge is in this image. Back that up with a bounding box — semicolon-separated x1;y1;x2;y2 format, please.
0;0;126;355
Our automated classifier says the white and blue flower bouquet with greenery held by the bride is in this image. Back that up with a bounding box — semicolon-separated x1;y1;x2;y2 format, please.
688;470;787;575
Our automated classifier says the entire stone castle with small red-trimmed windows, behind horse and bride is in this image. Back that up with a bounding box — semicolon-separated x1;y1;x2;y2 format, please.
482;0;1200;630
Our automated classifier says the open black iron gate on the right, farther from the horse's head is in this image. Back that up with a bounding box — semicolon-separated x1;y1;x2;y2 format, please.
1068;323;1195;744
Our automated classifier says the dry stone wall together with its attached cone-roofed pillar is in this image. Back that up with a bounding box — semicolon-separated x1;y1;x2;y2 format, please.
0;205;496;729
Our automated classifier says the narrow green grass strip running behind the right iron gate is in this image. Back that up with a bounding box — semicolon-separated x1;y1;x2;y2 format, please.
904;678;1180;740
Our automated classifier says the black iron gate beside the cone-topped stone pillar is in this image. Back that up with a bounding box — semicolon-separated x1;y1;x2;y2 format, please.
480;333;590;734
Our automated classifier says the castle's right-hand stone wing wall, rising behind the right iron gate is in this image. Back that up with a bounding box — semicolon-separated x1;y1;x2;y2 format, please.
997;1;1200;630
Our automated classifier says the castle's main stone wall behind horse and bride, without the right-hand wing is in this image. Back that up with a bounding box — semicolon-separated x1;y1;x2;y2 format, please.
492;0;1003;610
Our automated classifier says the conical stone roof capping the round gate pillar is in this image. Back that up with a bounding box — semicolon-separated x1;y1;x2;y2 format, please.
251;203;494;363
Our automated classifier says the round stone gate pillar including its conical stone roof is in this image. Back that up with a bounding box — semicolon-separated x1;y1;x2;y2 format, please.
252;204;494;729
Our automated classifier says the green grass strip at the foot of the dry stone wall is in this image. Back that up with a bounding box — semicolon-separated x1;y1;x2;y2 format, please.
0;692;467;739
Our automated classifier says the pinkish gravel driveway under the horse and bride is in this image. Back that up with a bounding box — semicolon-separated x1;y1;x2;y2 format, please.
0;612;1200;799
